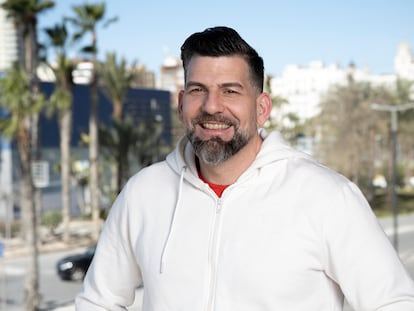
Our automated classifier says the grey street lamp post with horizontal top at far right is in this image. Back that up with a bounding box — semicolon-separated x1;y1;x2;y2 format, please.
371;103;414;252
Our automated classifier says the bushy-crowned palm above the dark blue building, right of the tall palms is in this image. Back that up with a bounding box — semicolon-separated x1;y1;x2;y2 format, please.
98;53;136;193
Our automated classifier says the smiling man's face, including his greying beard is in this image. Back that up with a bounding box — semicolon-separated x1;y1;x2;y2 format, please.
178;56;260;165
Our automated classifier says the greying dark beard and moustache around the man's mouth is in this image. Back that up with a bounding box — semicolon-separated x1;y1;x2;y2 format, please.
187;116;255;165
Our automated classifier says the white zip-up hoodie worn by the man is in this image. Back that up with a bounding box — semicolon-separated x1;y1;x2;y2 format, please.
76;131;414;311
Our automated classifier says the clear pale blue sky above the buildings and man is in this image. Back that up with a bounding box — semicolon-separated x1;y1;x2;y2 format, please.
39;0;414;76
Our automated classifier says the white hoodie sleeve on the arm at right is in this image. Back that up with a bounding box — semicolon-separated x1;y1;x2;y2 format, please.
324;182;414;311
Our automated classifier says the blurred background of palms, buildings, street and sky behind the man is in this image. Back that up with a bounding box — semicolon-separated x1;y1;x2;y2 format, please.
0;0;414;310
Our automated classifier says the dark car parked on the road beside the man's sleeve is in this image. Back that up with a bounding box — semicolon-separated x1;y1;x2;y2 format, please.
56;245;96;281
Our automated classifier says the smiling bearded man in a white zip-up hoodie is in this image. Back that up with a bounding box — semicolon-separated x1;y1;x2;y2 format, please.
76;27;414;311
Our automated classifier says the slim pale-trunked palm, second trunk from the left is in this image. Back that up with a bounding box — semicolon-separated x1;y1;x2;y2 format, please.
45;23;74;242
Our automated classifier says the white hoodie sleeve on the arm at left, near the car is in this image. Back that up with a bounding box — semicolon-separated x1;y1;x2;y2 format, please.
75;185;142;311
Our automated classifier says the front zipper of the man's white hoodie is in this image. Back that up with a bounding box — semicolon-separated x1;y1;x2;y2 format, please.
206;198;223;311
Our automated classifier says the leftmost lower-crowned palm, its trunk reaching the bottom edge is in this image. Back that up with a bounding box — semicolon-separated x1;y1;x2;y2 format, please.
0;65;43;310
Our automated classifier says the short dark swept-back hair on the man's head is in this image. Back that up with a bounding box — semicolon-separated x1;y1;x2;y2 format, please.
181;26;264;92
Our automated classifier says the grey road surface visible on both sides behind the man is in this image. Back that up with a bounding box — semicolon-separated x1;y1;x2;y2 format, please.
0;214;414;311
